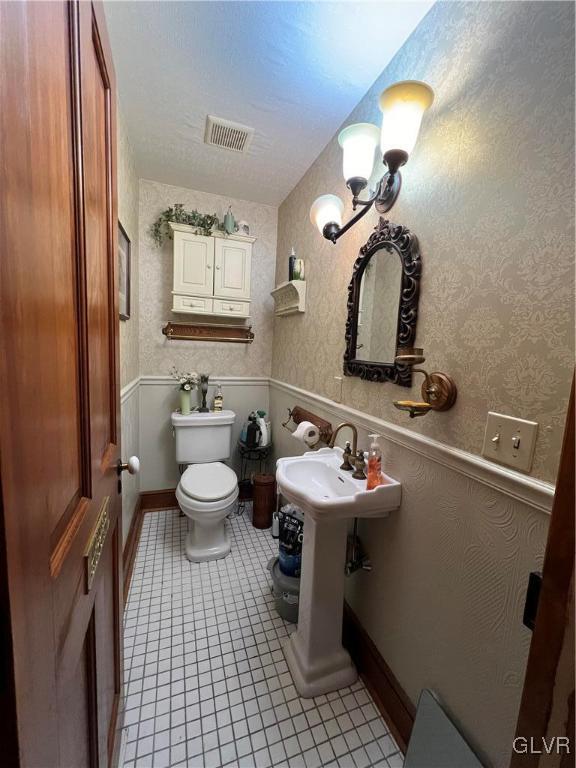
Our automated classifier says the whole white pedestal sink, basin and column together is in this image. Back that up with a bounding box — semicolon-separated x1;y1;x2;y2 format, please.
276;448;402;698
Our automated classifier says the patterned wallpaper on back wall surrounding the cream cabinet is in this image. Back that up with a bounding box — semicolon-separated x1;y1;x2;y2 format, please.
140;180;278;377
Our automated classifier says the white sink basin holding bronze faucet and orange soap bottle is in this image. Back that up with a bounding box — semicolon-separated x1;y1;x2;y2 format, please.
276;448;402;520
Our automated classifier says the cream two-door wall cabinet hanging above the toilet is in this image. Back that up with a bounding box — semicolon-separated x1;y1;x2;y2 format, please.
170;223;256;318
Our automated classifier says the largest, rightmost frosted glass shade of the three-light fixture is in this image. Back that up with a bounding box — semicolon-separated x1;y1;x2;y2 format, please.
380;80;434;155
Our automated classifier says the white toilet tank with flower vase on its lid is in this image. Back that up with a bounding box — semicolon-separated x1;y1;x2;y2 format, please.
172;411;236;464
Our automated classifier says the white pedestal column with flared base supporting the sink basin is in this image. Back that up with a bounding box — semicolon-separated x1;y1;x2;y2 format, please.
284;510;358;698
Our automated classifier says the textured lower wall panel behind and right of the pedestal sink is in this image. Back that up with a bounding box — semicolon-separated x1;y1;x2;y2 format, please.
270;381;553;768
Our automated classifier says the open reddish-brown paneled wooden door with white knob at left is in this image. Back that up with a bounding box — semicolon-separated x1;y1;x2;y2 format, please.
0;0;122;768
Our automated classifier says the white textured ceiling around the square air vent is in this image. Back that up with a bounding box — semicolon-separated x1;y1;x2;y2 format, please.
105;0;432;205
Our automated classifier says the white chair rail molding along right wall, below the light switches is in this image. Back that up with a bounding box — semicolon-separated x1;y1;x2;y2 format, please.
270;379;554;515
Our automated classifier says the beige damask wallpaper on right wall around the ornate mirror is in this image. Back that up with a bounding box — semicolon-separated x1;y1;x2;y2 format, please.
272;2;574;481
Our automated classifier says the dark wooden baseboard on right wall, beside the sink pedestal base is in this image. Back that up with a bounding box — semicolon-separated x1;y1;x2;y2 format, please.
342;603;416;753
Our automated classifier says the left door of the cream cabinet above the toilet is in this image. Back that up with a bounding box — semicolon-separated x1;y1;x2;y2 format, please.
174;232;214;296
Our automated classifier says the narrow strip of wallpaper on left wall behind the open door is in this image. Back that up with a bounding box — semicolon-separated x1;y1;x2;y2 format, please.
117;105;139;387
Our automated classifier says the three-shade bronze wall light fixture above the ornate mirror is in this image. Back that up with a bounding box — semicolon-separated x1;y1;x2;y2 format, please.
310;80;434;243
